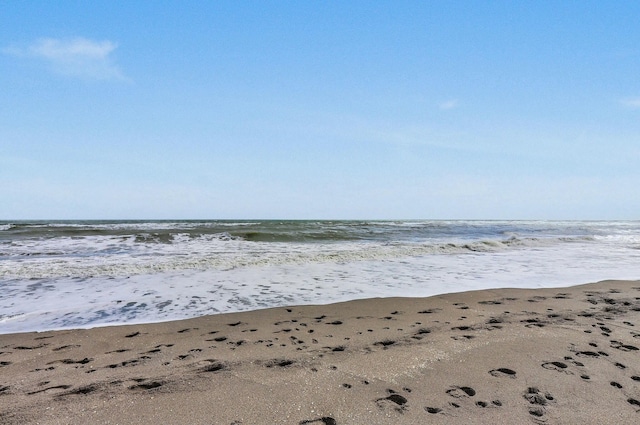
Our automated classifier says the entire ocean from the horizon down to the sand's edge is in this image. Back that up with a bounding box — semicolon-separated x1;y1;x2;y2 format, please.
0;220;640;334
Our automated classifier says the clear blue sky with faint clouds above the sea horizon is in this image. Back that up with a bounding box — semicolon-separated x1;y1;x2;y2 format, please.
0;1;640;220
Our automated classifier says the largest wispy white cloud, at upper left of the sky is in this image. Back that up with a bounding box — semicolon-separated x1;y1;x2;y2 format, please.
4;38;129;81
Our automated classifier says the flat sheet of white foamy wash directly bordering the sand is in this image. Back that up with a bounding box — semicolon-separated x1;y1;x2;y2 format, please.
0;238;640;333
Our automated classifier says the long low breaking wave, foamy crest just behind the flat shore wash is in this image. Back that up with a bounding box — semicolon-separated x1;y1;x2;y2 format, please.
0;237;592;279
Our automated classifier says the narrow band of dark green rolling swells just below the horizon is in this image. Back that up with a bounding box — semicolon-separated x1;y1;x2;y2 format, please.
0;220;640;243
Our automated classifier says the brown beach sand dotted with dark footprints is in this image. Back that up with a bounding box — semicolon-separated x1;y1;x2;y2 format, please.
0;281;640;425
